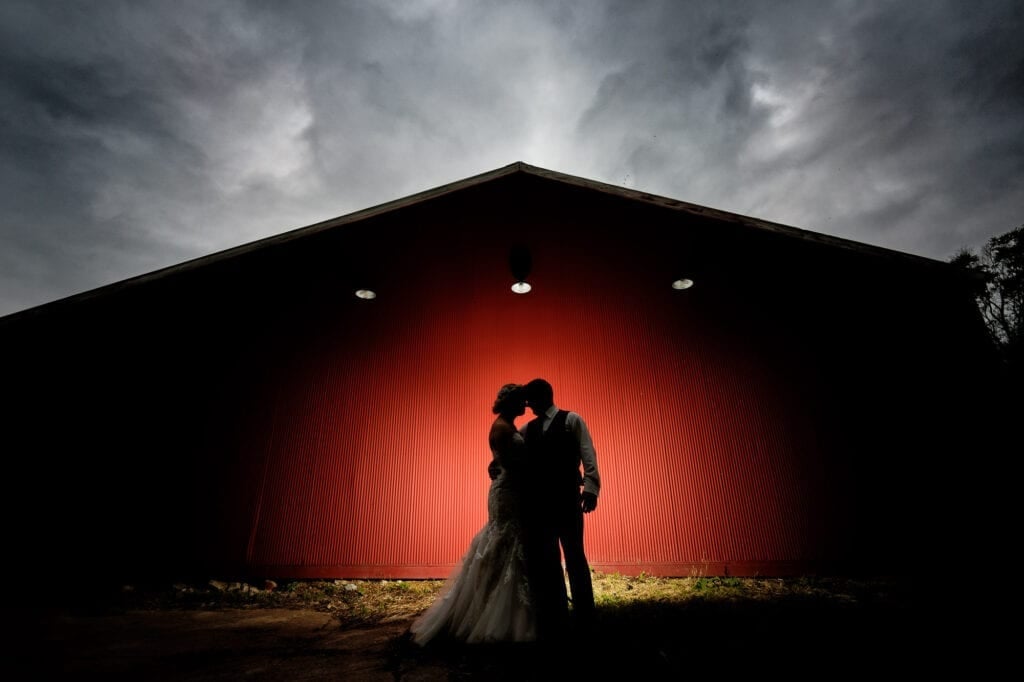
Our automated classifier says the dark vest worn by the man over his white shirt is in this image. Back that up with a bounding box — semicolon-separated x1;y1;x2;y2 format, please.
526;410;583;502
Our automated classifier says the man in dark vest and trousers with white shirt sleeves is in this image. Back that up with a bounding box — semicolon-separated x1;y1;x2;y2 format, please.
519;379;601;640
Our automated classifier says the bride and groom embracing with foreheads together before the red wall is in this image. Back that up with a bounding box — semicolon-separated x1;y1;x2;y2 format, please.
410;379;601;646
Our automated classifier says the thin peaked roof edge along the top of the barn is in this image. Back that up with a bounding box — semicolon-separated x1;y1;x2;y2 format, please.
0;161;953;322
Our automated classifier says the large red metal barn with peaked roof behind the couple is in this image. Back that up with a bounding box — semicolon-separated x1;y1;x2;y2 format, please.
0;163;989;580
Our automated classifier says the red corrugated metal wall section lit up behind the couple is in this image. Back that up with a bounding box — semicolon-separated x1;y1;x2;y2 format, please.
218;176;856;578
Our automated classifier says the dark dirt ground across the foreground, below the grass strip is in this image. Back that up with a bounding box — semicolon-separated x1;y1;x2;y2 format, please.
0;577;998;682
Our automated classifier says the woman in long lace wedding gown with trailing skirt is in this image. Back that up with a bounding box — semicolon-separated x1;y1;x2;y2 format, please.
410;384;536;645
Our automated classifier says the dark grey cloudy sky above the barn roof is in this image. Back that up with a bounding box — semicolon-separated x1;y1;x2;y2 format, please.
0;0;1024;315
